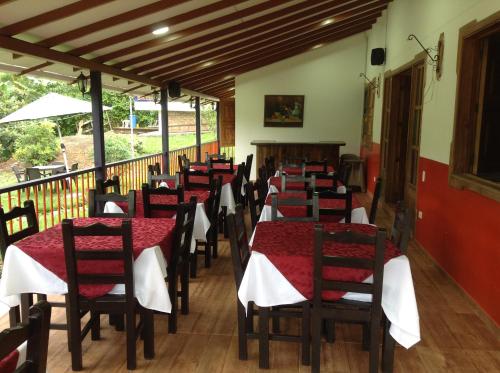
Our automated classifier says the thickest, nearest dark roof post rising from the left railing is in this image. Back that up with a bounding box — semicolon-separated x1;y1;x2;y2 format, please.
90;71;106;180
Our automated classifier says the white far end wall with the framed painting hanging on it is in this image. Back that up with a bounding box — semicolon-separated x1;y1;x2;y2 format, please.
235;34;366;177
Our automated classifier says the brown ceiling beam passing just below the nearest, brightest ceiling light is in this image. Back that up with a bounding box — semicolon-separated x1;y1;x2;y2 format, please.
113;0;343;68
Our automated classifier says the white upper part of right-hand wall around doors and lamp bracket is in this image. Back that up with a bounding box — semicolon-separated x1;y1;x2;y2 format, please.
367;0;500;164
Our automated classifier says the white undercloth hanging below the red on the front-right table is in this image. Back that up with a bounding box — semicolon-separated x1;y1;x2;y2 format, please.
238;251;420;348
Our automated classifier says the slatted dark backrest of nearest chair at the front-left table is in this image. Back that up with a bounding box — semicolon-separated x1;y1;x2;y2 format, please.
62;219;135;305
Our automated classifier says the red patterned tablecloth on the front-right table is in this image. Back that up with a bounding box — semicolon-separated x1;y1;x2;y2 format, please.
252;222;401;300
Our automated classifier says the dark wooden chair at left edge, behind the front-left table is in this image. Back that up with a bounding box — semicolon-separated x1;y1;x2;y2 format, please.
0;200;39;326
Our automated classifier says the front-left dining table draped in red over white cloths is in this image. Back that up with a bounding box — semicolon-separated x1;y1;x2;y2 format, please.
0;217;175;313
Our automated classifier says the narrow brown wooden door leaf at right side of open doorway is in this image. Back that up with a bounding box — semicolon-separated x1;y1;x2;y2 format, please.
405;60;425;227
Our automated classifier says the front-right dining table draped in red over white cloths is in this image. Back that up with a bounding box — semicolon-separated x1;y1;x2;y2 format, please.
238;221;420;348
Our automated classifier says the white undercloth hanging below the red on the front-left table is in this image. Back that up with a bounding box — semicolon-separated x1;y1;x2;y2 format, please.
0;245;172;313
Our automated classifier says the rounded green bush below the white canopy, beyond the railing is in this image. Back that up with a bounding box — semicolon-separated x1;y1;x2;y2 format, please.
14;121;59;166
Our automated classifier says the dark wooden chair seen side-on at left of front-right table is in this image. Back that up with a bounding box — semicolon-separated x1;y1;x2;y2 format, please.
227;204;310;368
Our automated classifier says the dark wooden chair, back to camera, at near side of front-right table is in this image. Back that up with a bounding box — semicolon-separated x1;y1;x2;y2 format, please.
312;225;386;373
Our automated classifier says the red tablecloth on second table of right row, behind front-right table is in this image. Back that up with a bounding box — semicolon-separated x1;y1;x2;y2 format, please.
266;192;361;222
